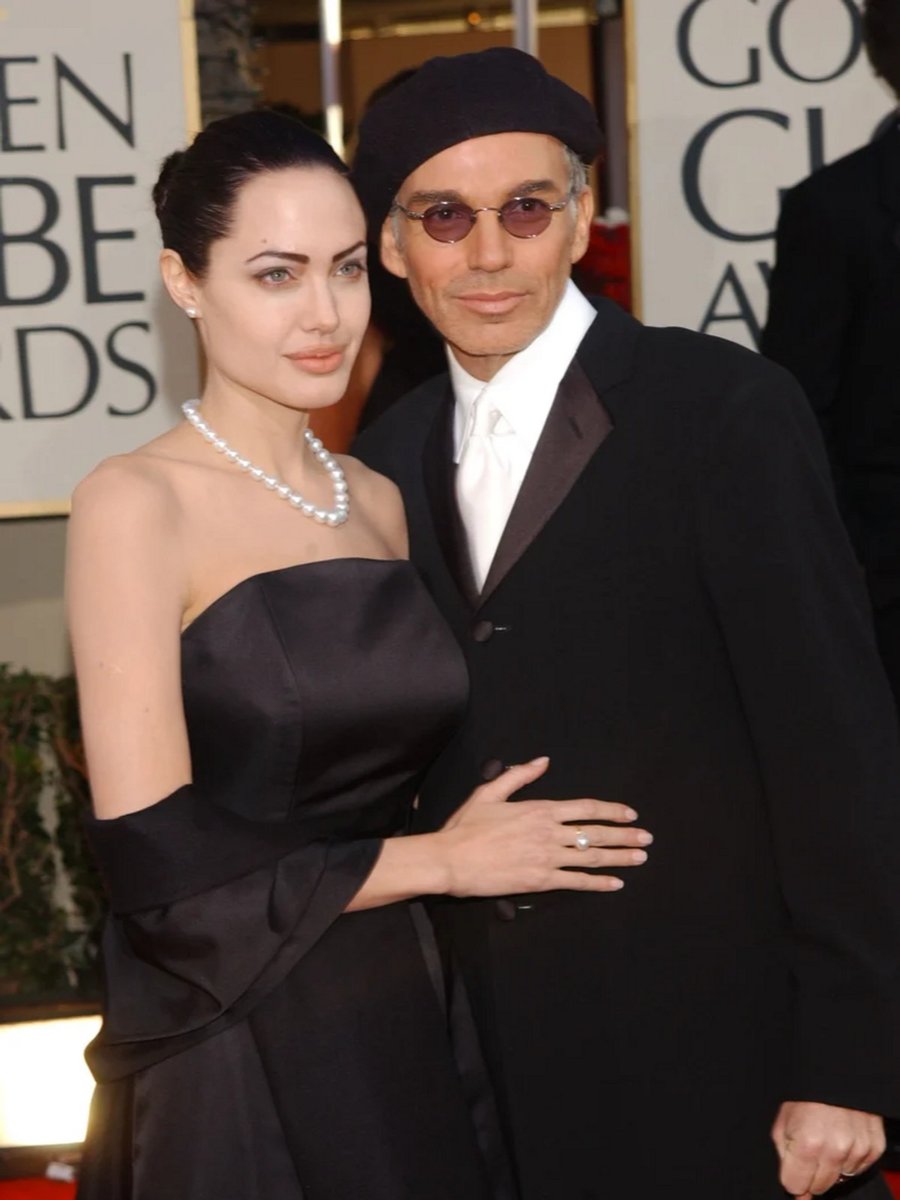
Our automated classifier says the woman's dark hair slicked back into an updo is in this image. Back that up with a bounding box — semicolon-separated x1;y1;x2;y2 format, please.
154;109;347;278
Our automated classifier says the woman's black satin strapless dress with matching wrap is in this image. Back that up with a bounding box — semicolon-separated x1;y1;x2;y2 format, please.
78;559;512;1200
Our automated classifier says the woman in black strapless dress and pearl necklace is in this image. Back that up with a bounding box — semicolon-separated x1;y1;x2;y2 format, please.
68;113;643;1200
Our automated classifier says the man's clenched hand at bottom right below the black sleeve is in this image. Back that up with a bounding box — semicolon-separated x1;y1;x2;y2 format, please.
772;1100;884;1200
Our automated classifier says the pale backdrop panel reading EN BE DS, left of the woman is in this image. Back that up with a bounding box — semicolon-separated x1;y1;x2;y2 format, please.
0;0;197;516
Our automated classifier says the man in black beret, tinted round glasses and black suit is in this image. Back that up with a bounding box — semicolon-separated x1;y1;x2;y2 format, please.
354;49;900;1200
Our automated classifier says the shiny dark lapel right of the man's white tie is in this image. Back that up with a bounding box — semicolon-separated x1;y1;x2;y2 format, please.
479;359;612;604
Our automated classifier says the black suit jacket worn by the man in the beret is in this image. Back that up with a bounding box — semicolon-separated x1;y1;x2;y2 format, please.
358;301;900;1200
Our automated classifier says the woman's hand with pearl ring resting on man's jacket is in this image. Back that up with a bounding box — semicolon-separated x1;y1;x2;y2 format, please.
433;758;653;896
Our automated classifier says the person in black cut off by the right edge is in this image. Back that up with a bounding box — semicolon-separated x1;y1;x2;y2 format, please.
761;0;900;703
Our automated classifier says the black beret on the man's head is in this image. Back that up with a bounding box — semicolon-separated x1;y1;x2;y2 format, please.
352;47;602;236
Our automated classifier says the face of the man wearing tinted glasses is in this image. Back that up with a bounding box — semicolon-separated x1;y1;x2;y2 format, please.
382;133;593;379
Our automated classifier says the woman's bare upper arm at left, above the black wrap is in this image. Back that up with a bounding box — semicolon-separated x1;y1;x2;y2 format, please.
66;458;191;817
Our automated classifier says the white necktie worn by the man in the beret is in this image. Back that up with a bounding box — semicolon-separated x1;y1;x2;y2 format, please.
456;391;518;592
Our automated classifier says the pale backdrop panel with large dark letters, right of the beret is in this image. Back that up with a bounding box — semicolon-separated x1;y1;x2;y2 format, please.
626;0;893;348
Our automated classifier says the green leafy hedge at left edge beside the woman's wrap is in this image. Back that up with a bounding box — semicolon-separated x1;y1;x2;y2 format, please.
0;665;103;1004
